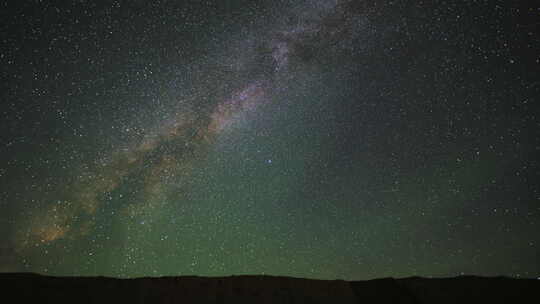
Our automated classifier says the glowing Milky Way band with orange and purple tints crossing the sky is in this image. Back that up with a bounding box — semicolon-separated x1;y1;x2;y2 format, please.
10;1;368;274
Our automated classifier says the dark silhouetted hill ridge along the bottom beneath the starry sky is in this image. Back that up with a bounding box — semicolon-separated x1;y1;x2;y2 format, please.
0;273;540;304
